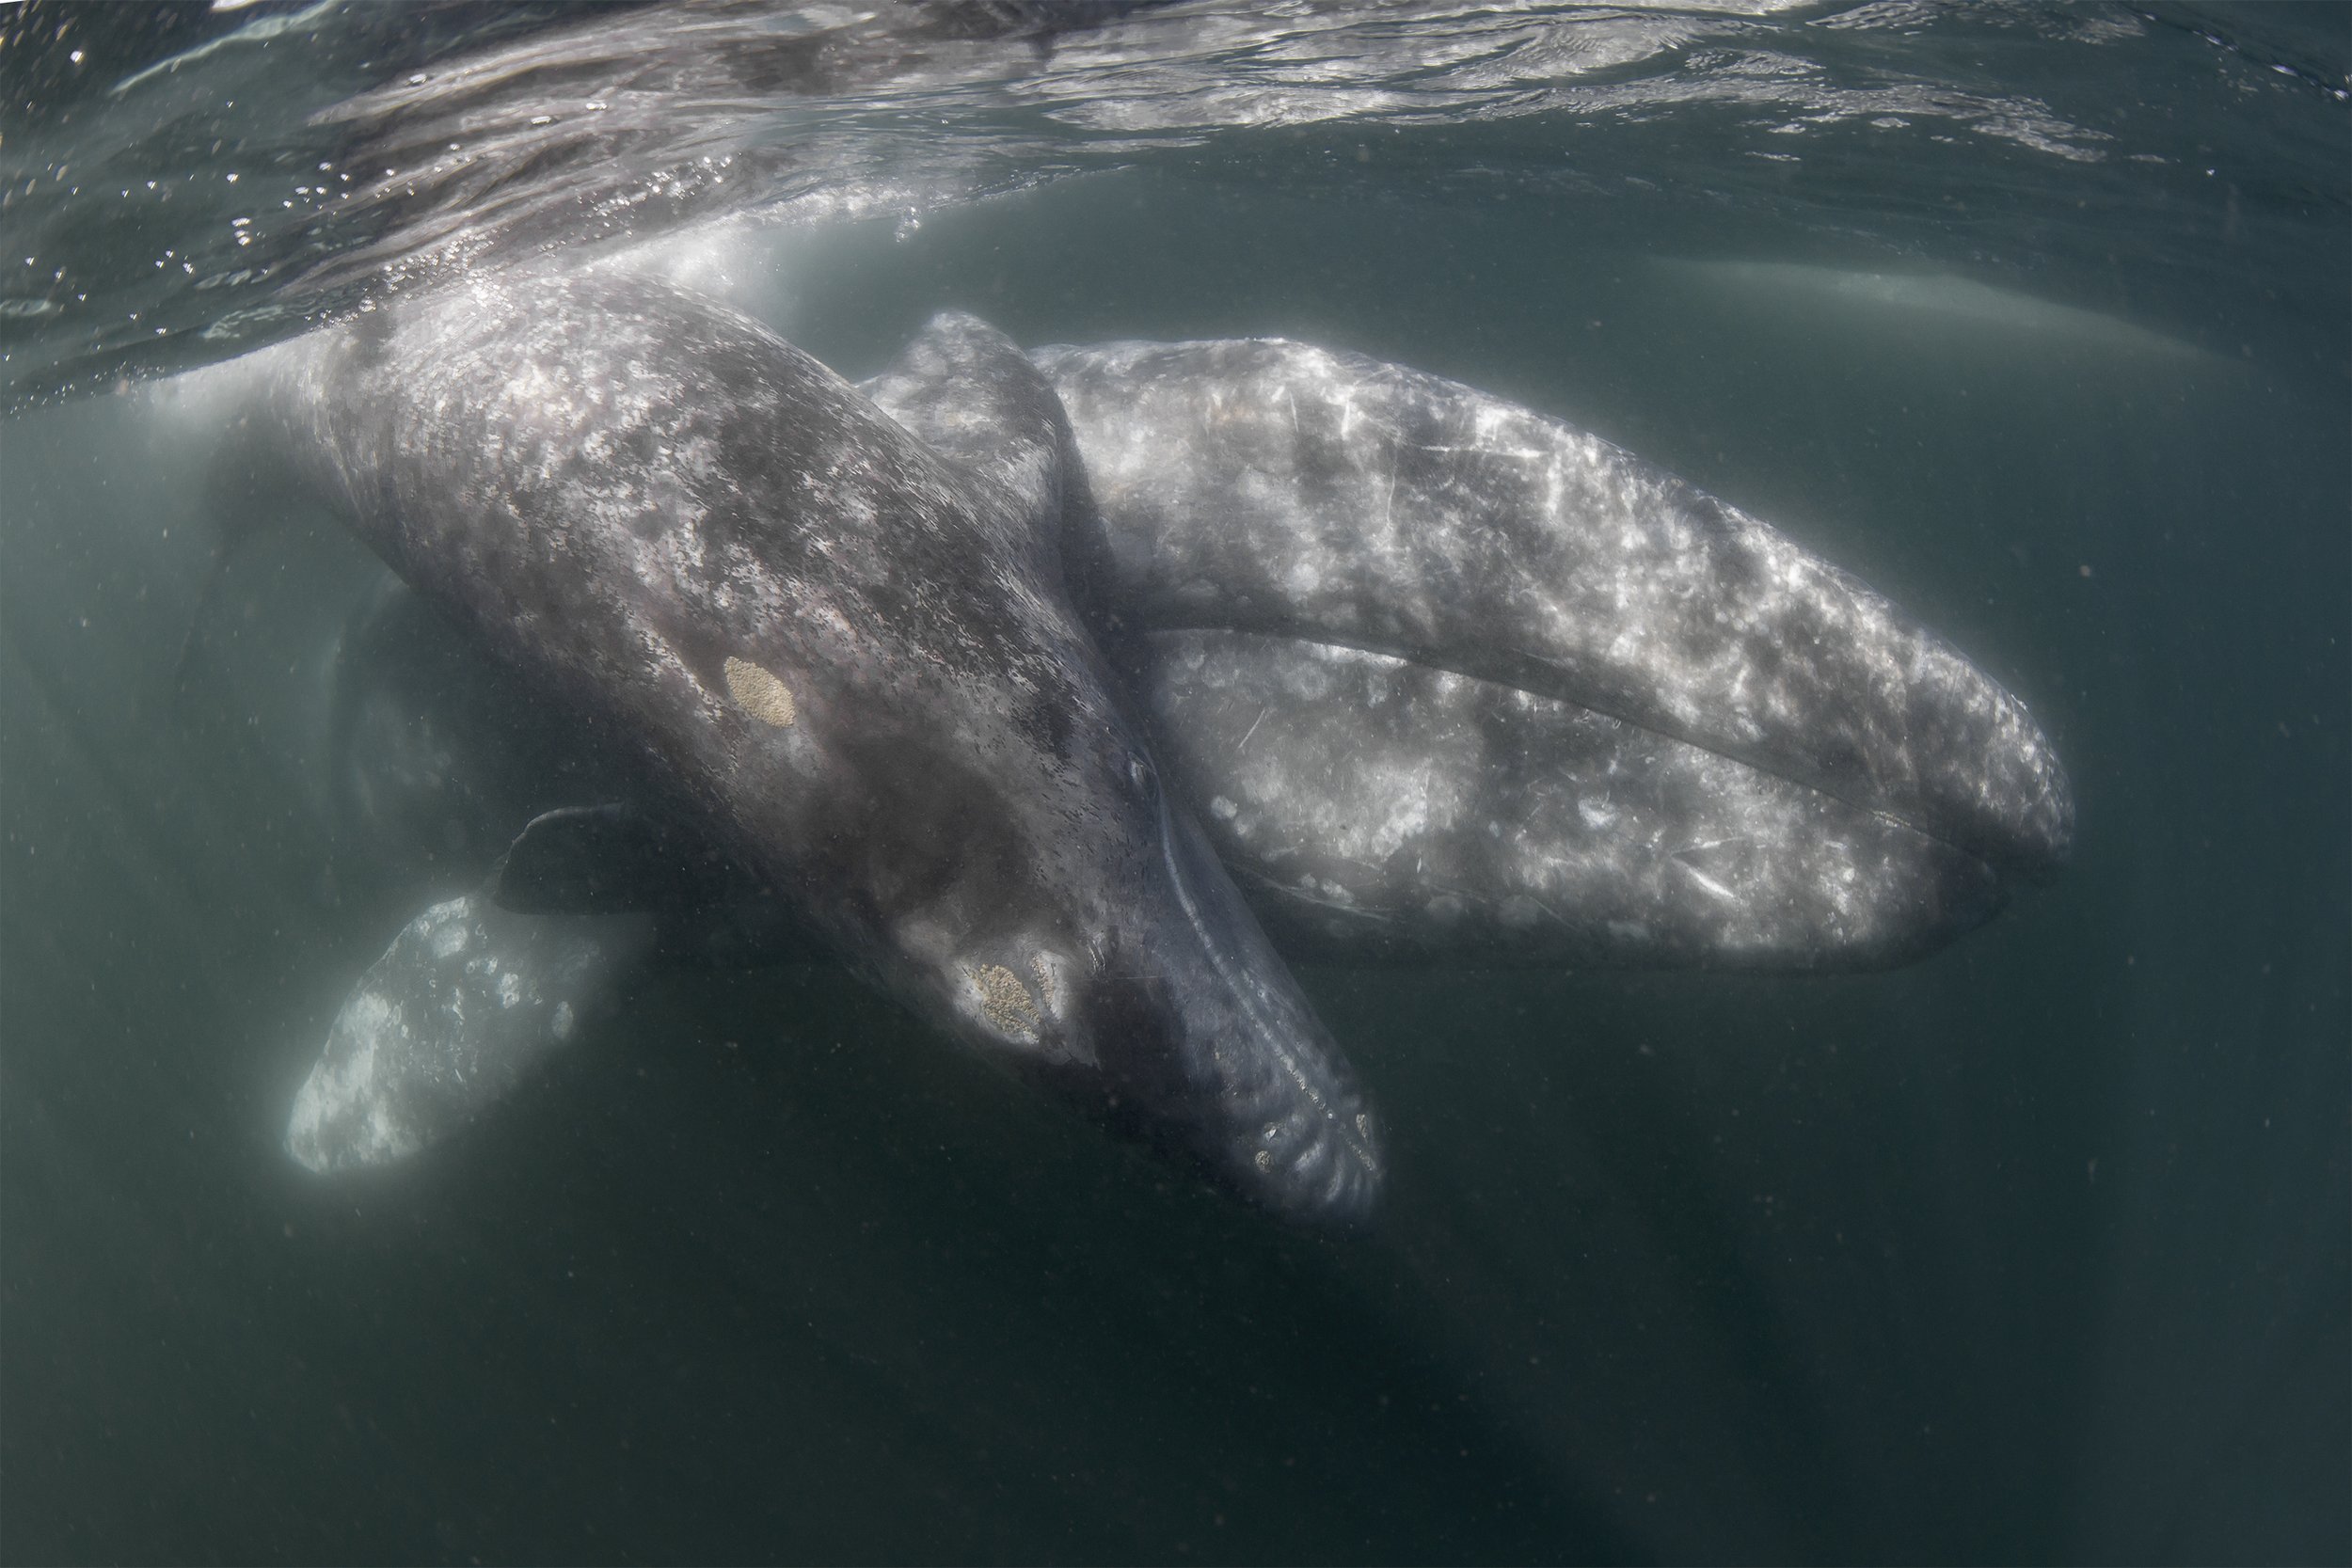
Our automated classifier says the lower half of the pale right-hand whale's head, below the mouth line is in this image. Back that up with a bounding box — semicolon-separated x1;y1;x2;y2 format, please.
1136;632;2002;969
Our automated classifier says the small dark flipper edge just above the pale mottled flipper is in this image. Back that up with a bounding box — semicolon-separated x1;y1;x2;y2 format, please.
487;804;757;914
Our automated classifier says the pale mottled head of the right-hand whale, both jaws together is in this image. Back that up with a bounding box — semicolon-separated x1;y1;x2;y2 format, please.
1038;341;2073;969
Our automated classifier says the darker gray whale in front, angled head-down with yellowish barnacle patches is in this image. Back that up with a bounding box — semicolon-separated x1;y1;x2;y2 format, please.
191;273;1381;1225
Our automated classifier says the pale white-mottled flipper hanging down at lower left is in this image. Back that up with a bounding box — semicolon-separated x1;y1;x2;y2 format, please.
287;891;654;1171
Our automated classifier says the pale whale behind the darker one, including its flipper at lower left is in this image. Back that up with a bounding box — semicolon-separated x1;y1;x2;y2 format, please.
183;281;2070;1222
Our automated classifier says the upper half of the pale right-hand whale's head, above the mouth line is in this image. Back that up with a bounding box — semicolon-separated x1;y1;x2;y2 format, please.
1035;339;2073;872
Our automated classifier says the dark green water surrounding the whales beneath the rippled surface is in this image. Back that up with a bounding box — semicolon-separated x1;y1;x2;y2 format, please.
0;7;2352;1561
